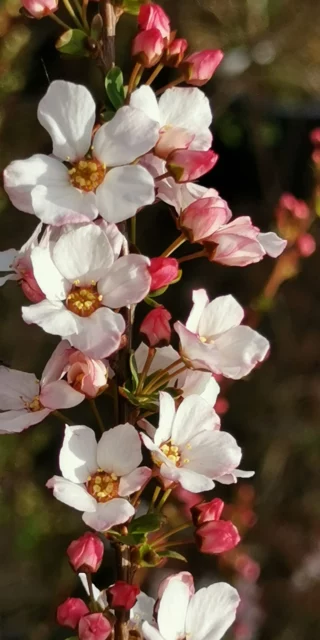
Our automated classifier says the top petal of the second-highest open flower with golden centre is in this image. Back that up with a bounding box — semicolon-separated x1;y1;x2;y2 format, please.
52;224;113;286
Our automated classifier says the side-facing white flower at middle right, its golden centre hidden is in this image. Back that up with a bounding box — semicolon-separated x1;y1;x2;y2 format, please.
174;289;270;380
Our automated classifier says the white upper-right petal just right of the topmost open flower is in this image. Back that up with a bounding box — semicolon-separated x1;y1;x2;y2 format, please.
159;87;212;150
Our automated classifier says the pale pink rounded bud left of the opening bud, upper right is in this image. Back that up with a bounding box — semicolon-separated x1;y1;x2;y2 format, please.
180;196;231;242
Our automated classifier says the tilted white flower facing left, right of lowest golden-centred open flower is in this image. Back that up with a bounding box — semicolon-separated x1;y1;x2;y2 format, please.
140;392;241;493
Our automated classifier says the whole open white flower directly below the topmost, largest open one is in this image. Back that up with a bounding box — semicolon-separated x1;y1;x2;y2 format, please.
22;223;151;359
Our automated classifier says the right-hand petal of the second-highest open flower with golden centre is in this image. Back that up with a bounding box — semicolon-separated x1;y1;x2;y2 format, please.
98;253;151;308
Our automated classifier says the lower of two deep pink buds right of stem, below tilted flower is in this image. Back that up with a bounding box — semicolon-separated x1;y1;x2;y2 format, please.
195;520;240;554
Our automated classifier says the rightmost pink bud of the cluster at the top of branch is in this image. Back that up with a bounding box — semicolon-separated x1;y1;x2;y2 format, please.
180;49;223;87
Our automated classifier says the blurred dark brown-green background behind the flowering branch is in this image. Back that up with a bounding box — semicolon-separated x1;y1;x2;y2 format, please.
0;0;320;640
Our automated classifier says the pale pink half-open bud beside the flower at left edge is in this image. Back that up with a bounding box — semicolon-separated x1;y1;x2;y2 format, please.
67;351;108;398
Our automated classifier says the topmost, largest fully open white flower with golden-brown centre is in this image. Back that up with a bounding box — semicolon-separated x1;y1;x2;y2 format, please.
4;80;158;225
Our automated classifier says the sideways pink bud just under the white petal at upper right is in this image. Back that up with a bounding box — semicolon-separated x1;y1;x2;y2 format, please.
166;149;219;183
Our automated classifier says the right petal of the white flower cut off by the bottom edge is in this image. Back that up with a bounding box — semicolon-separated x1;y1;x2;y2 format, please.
186;582;240;640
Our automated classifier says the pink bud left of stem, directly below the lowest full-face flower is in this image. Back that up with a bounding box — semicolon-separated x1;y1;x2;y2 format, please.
67;532;104;573
